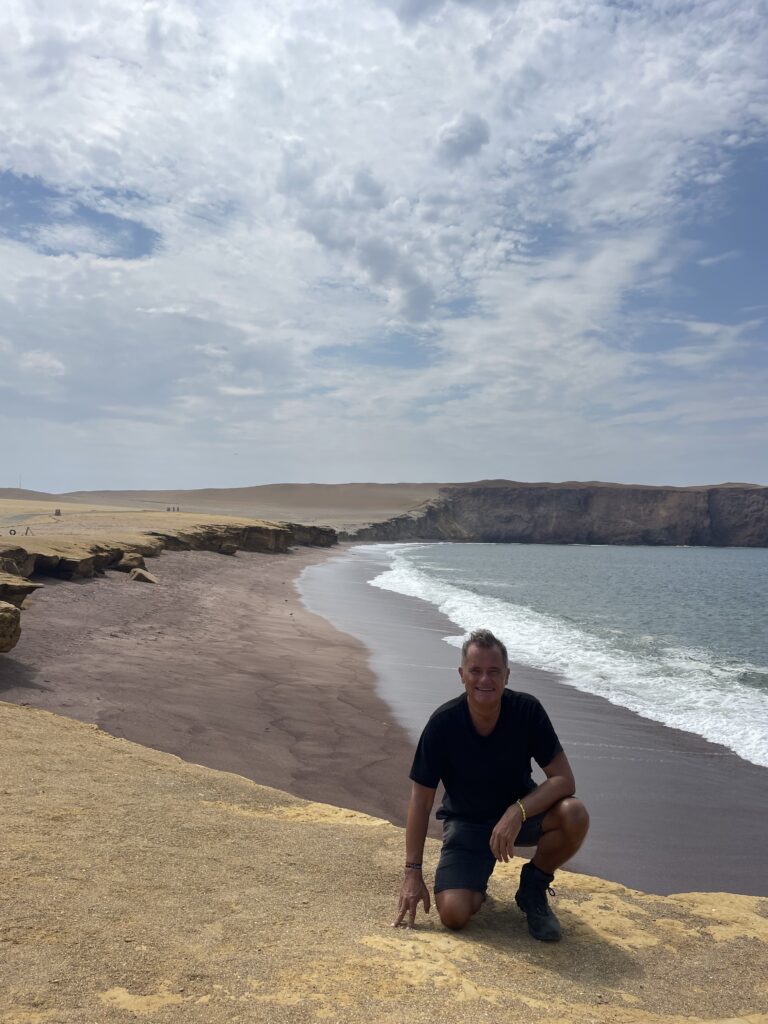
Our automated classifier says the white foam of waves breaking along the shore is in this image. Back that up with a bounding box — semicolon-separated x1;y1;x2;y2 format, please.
370;545;768;767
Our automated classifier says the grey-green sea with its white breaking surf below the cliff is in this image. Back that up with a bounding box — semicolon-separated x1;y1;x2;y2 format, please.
304;543;768;766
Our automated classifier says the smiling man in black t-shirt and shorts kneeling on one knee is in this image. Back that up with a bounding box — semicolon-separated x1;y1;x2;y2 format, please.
394;630;589;942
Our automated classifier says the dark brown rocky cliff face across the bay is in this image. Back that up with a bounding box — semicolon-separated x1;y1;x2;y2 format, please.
353;480;768;547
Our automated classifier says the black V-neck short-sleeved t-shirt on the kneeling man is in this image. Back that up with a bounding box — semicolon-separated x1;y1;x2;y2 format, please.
411;689;562;821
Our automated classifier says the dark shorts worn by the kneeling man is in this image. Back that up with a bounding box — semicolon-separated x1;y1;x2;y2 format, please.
434;811;547;893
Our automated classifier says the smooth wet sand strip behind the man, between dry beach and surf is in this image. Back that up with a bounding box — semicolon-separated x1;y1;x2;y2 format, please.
300;550;768;896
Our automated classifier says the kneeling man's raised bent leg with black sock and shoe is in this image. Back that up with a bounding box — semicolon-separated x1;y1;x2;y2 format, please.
515;797;589;942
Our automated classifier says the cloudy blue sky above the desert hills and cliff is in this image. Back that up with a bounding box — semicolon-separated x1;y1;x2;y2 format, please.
0;0;768;492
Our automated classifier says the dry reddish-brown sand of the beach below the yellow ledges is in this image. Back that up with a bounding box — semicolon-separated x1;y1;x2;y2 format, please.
0;548;411;821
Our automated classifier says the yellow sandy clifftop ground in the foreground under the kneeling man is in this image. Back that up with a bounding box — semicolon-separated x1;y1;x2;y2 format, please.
0;703;768;1024
